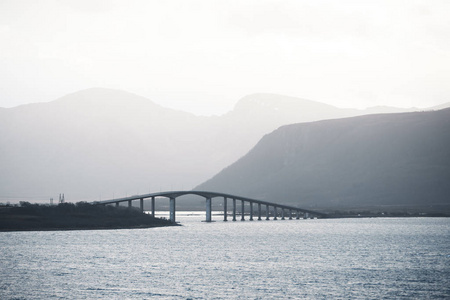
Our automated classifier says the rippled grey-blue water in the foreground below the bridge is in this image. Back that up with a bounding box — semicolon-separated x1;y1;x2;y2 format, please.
0;216;450;299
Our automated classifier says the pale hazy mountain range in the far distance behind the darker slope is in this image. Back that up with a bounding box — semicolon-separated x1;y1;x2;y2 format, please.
0;88;446;201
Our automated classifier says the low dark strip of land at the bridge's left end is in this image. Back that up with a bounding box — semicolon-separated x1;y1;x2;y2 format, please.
0;202;178;231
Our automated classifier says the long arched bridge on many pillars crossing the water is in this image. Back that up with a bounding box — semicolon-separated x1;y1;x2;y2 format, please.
93;191;327;222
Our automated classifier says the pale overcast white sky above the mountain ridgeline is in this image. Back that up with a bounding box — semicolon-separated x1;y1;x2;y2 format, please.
0;0;450;115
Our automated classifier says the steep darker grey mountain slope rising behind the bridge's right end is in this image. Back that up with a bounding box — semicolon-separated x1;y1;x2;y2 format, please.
196;109;450;209
